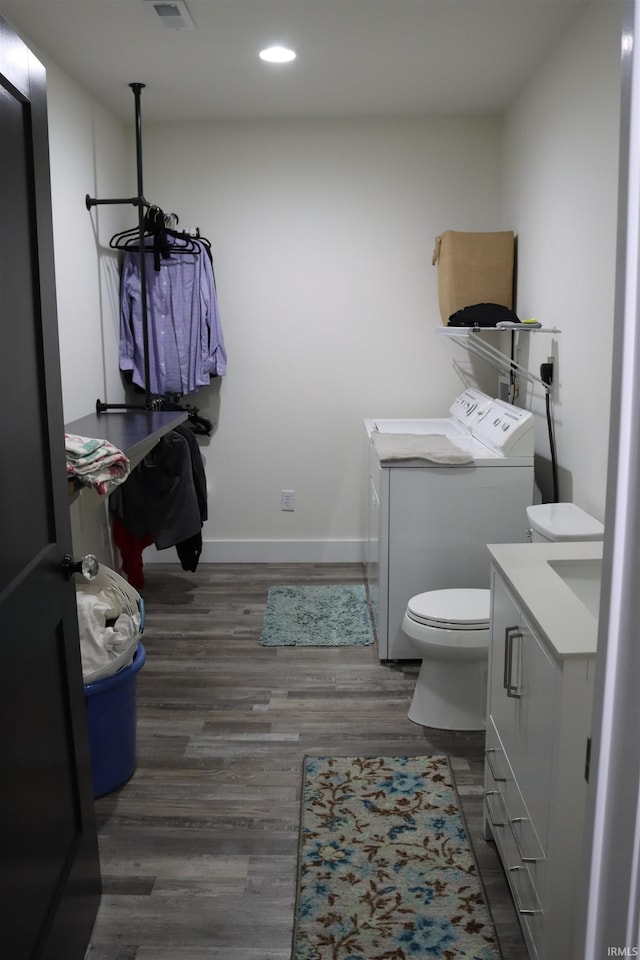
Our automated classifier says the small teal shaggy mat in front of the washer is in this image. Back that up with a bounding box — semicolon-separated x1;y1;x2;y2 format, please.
260;584;373;647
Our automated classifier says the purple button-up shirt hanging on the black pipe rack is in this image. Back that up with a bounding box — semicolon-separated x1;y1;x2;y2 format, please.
120;244;227;394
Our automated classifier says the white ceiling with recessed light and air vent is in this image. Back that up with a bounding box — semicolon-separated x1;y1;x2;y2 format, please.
0;0;592;122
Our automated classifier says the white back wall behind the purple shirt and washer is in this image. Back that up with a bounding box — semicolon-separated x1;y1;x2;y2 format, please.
138;118;502;560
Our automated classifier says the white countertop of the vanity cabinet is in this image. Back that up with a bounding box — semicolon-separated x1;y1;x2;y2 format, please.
488;541;603;658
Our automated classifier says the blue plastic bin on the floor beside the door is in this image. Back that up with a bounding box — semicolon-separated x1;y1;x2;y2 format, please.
84;641;146;797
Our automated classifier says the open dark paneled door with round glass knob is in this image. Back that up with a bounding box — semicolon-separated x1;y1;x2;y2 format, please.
0;18;100;960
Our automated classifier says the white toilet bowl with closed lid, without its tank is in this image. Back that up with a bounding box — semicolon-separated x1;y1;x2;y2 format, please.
402;589;491;730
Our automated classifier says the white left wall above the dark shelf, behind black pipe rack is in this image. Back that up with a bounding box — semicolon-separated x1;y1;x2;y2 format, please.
45;60;129;423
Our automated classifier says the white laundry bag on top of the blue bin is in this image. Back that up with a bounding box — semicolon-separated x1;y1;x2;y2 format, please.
76;564;144;684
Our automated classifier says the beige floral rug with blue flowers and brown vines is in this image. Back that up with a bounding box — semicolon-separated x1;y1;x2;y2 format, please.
292;756;500;960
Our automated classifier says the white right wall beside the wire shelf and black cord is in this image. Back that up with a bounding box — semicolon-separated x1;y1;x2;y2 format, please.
505;0;623;520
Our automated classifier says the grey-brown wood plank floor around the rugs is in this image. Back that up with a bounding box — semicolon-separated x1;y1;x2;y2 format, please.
88;564;527;960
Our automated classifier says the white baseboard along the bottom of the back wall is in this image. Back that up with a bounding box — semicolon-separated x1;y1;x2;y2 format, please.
143;540;367;563
